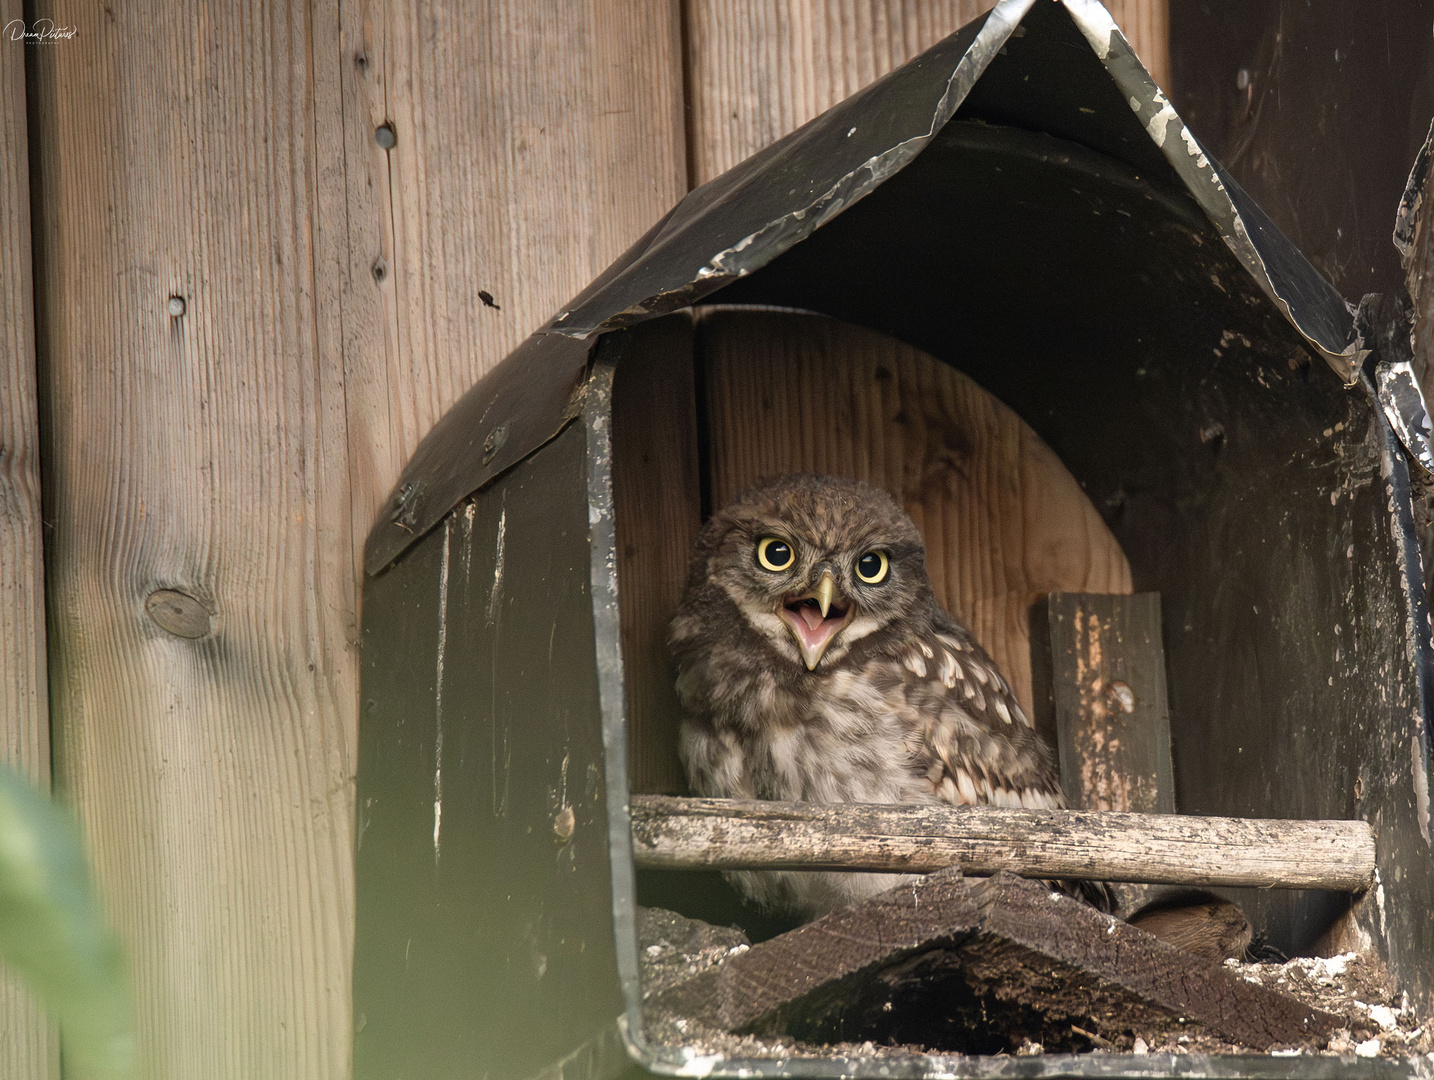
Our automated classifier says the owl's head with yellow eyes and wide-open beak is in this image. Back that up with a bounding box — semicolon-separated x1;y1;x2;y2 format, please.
684;475;931;671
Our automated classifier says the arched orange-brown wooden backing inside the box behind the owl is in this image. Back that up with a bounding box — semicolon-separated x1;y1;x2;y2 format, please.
698;310;1131;713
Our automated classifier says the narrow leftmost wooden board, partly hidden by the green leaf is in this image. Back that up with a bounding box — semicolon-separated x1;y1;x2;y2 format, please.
0;0;60;1080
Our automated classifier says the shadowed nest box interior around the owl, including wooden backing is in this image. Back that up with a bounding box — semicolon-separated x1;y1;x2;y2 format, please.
614;111;1424;975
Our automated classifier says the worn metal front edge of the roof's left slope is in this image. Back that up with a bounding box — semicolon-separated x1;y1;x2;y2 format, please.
539;0;1035;338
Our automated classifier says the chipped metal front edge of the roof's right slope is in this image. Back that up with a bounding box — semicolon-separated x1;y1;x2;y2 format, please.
1060;0;1361;387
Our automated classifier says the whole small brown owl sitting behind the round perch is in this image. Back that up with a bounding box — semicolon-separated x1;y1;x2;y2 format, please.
668;475;1064;916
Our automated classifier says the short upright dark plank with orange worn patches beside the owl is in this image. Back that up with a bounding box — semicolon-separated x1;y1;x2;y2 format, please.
1037;592;1174;813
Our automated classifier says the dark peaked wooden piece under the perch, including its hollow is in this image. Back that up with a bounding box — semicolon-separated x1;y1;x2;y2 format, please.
652;872;1344;1053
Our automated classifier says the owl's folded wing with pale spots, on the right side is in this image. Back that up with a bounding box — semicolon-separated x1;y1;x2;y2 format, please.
872;612;1065;809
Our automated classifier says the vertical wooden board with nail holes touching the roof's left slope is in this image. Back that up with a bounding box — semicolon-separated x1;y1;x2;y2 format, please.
338;0;687;565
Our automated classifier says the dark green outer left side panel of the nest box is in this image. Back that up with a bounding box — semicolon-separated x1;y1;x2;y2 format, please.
354;423;625;1080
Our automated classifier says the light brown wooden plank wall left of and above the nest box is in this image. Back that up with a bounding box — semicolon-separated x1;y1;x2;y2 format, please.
11;0;1163;1080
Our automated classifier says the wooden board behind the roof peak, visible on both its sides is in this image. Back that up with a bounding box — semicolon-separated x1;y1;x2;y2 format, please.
684;0;1170;185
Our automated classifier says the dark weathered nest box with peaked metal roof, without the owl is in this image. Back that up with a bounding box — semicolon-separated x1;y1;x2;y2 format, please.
354;0;1434;1080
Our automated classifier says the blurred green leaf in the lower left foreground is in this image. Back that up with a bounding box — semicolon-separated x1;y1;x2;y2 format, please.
0;766;135;1074
